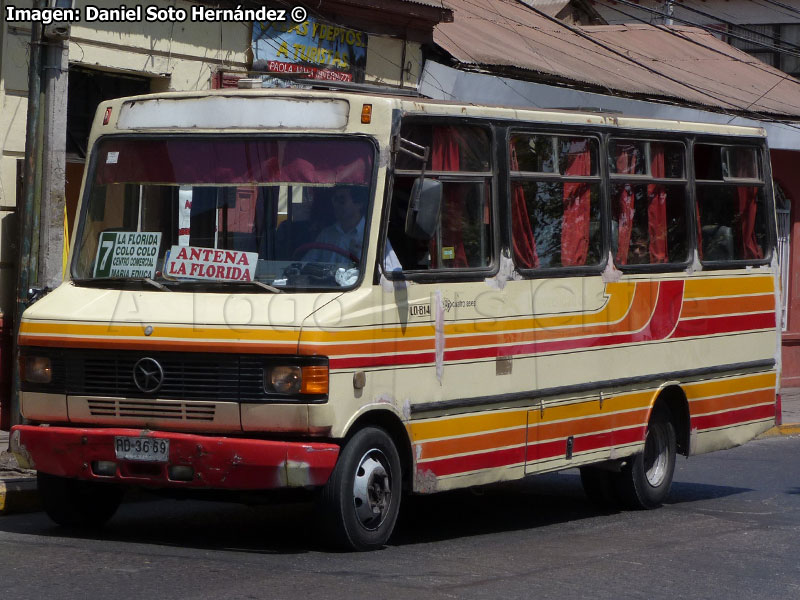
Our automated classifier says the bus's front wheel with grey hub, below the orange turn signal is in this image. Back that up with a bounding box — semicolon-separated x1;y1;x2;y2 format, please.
319;427;402;551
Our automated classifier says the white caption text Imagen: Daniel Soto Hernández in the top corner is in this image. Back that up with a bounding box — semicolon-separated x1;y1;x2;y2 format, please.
4;4;287;25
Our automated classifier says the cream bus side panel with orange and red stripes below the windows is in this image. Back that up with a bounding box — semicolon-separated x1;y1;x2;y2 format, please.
300;269;775;491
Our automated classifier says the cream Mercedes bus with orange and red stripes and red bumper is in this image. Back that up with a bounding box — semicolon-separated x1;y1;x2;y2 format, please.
11;84;780;550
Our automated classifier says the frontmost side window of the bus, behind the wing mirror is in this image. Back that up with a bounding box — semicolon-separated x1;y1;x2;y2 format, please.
387;123;493;271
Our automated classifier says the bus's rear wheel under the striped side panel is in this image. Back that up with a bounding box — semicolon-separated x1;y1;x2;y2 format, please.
614;404;677;510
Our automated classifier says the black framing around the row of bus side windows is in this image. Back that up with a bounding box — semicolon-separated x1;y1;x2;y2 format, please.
374;116;777;284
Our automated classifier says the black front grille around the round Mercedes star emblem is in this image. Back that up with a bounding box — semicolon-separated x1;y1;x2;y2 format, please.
23;348;327;404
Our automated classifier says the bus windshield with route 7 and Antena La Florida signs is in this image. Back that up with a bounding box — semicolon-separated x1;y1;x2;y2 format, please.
72;136;374;289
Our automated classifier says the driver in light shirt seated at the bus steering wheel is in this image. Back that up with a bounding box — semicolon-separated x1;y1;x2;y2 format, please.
303;186;402;271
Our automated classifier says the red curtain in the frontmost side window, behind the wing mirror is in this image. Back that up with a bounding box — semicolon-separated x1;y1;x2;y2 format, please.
431;127;469;268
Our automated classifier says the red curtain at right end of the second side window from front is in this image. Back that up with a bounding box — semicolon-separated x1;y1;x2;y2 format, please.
561;140;592;267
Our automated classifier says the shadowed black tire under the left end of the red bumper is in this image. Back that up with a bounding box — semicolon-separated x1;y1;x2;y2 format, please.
36;472;124;529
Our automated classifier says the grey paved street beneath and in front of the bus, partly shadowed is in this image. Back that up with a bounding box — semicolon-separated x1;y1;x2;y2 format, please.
0;436;800;600
